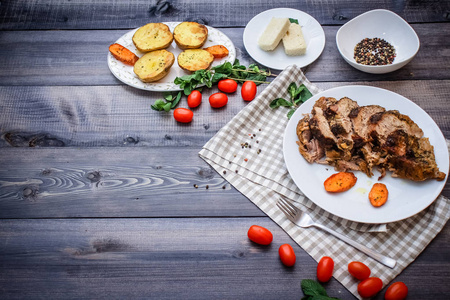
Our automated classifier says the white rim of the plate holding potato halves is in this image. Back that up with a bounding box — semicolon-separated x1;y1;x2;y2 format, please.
107;22;236;92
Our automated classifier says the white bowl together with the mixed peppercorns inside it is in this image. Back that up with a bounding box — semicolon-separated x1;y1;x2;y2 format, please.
336;9;420;74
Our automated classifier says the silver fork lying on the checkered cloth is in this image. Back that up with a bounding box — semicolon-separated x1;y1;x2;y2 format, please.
277;197;397;269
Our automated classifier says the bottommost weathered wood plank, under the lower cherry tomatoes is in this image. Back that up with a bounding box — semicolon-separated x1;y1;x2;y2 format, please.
0;218;450;299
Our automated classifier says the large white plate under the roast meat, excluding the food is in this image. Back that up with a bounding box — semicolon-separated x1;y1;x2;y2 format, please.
283;86;449;224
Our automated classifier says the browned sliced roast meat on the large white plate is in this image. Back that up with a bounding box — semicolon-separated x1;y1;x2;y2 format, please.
297;97;446;181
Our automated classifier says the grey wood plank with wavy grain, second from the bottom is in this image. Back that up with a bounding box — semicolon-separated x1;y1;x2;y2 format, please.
0;147;265;218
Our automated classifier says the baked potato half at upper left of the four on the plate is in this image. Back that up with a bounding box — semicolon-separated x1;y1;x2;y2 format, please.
132;23;173;52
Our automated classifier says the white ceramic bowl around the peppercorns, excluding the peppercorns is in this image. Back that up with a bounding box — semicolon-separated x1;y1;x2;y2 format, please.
336;9;420;74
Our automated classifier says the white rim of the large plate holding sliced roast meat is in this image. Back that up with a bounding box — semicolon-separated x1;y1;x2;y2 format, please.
283;85;449;224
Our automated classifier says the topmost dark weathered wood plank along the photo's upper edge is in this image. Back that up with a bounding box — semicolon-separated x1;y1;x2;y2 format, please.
0;0;450;30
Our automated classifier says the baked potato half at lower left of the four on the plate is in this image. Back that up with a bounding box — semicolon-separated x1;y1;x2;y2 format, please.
134;49;175;82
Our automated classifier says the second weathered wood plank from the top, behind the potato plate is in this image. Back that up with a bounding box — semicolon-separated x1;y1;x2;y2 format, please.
0;23;450;86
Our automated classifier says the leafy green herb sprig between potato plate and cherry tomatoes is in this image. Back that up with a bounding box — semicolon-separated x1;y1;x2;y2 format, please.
174;59;276;96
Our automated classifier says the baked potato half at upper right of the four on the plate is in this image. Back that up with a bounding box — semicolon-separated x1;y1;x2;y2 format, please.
173;22;208;50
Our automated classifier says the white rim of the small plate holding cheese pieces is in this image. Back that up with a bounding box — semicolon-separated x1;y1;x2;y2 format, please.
242;7;326;70
